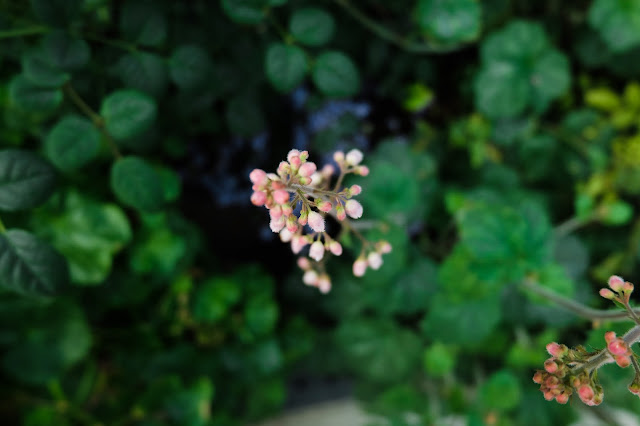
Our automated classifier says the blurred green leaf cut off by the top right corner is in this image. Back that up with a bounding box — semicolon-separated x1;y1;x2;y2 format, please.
588;0;640;53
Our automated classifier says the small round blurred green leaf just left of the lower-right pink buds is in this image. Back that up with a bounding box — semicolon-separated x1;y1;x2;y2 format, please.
478;370;522;411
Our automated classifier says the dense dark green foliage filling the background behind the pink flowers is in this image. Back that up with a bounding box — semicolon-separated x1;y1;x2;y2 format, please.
0;0;640;426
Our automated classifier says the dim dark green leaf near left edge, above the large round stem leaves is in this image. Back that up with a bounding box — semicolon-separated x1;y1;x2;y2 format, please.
9;74;62;113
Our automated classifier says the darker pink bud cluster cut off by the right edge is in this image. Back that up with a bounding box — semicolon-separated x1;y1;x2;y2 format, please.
533;275;640;405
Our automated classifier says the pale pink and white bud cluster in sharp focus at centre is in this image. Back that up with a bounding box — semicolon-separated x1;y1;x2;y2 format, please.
249;149;391;293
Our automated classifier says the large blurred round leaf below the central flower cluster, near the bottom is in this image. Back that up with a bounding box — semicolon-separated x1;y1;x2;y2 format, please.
336;319;422;382
